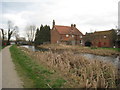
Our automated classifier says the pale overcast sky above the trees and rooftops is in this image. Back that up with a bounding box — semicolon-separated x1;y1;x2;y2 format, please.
0;0;119;36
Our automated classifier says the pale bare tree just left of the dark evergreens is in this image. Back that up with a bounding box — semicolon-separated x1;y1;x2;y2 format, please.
26;25;36;43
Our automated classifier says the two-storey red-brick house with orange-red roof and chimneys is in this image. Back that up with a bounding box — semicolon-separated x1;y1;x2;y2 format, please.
51;20;83;45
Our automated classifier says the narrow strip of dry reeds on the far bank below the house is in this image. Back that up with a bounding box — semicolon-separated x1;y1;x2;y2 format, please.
39;44;120;56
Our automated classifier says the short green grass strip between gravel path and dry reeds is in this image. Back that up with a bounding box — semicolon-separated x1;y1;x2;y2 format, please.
10;46;66;88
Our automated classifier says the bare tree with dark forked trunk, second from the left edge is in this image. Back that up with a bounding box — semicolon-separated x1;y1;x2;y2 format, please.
7;21;18;44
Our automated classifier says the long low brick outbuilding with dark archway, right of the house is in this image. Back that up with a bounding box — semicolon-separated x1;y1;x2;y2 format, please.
83;29;116;47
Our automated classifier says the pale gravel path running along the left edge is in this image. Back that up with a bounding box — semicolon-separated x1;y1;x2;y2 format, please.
2;46;22;88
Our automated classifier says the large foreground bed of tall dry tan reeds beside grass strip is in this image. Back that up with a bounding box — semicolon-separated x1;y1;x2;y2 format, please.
20;48;117;88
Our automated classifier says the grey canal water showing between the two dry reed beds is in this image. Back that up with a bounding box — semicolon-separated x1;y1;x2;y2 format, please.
21;45;120;66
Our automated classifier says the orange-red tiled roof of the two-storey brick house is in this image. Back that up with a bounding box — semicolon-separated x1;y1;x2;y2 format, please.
54;25;83;35
